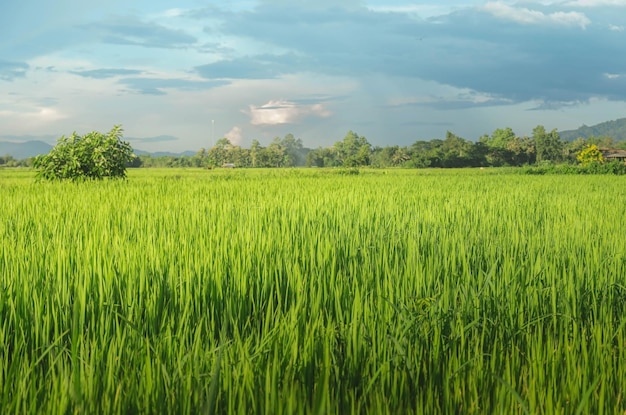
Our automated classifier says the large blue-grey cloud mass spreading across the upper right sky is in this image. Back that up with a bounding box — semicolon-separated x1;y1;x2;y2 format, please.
189;1;626;108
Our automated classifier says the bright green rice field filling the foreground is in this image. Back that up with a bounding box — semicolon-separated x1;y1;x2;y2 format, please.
0;169;626;414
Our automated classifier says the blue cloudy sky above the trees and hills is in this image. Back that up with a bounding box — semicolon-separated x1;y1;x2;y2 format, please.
0;0;626;152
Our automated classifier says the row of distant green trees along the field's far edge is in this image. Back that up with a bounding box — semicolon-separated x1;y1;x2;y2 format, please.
131;125;626;168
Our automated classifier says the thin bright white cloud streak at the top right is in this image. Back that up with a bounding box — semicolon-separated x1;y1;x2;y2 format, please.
483;2;591;29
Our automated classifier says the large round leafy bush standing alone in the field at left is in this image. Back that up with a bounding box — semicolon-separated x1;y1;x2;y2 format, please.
33;125;136;180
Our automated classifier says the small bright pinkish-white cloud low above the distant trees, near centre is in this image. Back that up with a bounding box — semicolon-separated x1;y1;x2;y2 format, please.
249;100;331;125
